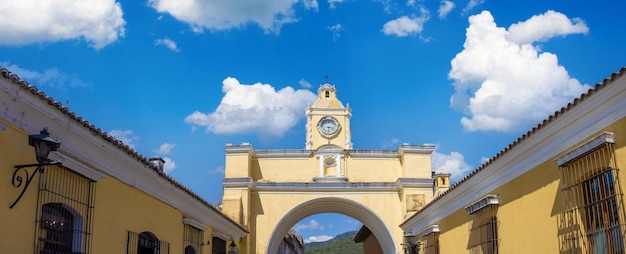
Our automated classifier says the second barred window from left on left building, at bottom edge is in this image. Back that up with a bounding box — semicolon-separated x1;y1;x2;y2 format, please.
126;231;170;254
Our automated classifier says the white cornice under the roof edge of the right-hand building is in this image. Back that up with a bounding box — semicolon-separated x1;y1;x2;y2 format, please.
400;75;626;232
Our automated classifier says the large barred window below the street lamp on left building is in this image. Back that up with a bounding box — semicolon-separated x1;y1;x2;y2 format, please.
35;165;96;254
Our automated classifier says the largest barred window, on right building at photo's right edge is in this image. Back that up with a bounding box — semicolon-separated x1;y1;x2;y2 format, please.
557;133;626;253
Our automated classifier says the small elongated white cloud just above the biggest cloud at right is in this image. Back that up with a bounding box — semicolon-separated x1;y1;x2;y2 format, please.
507;10;589;44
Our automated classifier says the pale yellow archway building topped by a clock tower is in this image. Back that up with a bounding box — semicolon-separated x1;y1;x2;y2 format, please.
223;84;435;254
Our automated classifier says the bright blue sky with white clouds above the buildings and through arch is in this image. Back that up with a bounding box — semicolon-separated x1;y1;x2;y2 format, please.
0;0;626;243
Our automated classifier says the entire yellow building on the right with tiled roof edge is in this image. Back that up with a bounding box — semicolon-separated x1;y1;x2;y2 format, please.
400;68;626;253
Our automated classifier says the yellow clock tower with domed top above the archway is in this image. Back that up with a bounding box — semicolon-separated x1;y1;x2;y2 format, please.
306;83;352;150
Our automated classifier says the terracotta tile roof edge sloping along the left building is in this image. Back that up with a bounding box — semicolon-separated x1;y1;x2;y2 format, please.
0;66;248;232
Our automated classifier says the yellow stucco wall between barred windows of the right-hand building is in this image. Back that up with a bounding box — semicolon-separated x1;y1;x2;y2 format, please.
435;118;626;253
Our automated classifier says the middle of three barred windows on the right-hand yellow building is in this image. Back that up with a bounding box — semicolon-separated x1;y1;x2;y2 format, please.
466;195;500;254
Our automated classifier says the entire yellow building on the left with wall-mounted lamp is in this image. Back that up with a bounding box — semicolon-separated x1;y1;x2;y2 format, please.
0;67;247;254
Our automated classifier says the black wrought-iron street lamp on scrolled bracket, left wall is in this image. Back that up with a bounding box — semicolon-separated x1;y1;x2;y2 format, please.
9;128;61;208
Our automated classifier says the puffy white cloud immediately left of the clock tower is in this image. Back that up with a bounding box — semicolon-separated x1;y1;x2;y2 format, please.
185;77;317;137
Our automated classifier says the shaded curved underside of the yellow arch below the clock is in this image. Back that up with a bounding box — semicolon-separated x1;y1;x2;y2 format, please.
266;197;398;254
